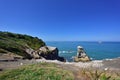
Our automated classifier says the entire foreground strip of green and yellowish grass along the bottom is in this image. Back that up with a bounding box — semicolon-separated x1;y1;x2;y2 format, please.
0;62;120;80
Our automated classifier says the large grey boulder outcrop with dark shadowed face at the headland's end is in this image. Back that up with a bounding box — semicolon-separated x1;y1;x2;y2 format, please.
26;46;65;61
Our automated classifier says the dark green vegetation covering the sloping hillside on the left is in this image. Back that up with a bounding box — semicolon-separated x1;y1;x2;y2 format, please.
0;31;45;57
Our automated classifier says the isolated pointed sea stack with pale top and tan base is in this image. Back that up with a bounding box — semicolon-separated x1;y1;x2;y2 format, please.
74;46;90;62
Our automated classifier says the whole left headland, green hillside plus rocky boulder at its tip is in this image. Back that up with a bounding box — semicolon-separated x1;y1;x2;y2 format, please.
0;31;65;61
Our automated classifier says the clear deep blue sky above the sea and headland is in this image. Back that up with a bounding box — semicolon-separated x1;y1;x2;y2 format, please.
0;0;120;41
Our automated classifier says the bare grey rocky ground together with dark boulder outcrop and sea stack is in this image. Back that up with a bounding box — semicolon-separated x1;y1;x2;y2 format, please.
0;46;120;72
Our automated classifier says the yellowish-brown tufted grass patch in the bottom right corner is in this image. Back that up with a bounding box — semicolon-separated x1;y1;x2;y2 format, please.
79;69;120;80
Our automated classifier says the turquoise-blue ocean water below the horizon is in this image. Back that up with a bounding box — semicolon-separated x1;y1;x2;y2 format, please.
46;41;120;62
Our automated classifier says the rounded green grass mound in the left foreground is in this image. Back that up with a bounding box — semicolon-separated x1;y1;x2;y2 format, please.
0;63;74;80
